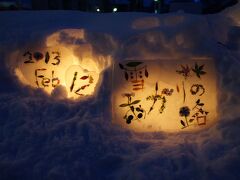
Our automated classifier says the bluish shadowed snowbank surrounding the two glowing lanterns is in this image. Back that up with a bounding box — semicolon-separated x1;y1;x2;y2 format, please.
0;3;240;180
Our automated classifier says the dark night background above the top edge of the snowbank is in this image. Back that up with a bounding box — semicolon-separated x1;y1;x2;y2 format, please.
0;0;238;14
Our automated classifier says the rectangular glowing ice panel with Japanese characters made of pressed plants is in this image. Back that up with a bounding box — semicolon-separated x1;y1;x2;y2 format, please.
112;59;217;132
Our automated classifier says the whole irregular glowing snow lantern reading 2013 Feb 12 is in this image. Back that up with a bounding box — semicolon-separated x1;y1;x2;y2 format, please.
15;29;109;99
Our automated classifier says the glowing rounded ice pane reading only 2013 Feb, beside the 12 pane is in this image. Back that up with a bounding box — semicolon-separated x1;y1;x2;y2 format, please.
16;46;75;94
